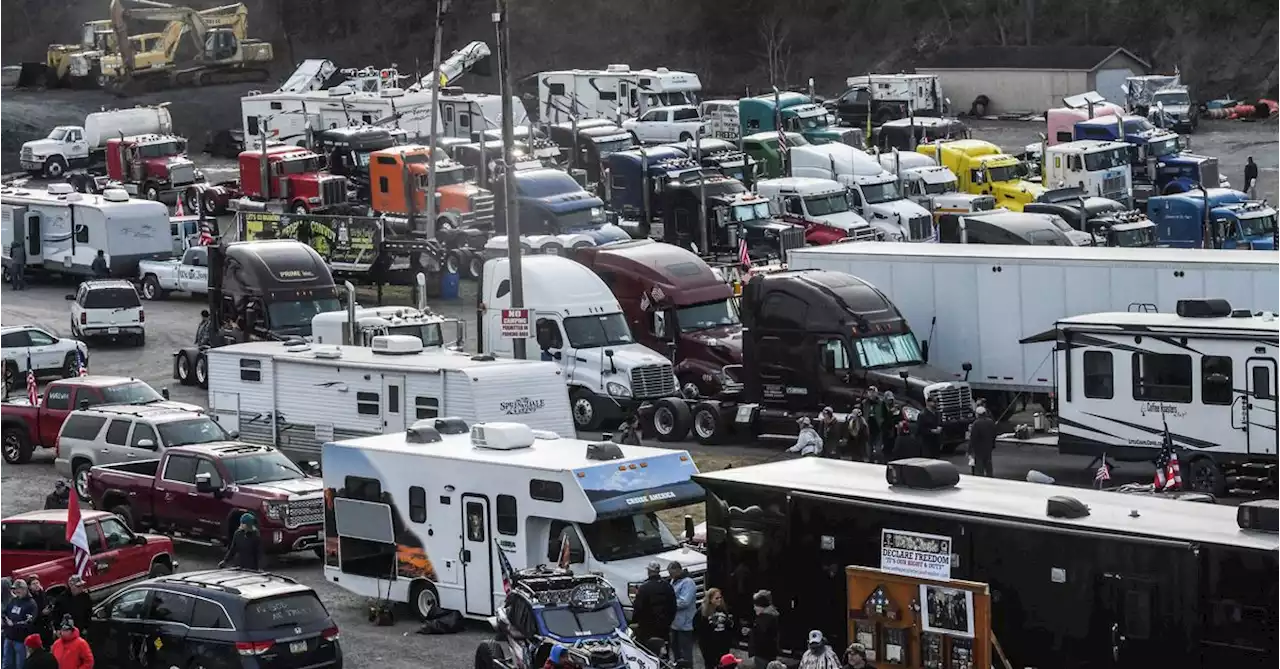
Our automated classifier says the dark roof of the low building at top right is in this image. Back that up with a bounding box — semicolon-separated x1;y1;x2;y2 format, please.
916;46;1151;72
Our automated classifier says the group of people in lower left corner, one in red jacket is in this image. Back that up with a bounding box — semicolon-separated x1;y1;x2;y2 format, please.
0;576;93;669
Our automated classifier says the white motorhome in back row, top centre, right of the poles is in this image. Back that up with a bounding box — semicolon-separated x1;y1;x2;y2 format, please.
535;65;703;123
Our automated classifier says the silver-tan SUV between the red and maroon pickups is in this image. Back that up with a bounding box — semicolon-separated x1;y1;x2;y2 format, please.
54;402;236;499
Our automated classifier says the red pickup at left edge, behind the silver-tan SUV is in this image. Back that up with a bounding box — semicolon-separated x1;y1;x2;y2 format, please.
0;375;204;464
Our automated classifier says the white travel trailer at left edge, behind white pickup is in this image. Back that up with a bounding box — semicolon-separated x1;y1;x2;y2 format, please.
0;183;173;279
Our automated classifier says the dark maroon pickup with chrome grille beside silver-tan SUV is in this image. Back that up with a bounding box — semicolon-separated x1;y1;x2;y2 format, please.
86;441;324;555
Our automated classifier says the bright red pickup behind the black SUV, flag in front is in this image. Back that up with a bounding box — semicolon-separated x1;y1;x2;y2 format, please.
0;509;178;596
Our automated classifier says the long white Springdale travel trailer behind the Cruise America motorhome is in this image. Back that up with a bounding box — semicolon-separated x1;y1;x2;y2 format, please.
206;335;573;455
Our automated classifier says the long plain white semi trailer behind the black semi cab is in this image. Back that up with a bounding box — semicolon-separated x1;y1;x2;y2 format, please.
788;242;1280;405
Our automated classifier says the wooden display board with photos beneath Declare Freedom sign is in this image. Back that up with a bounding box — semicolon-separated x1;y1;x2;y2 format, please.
841;567;991;669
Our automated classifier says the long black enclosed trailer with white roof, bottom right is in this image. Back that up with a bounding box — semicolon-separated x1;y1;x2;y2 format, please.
694;458;1280;669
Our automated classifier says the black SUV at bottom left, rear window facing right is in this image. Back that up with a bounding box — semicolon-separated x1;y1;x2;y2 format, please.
87;569;342;669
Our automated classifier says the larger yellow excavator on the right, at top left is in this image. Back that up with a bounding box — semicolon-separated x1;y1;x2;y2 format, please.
101;0;275;95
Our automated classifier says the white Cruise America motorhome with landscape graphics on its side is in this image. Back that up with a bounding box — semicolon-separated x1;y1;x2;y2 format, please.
314;418;705;619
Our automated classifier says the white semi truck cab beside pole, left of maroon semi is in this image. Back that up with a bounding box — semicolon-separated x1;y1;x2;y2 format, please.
480;255;684;440
